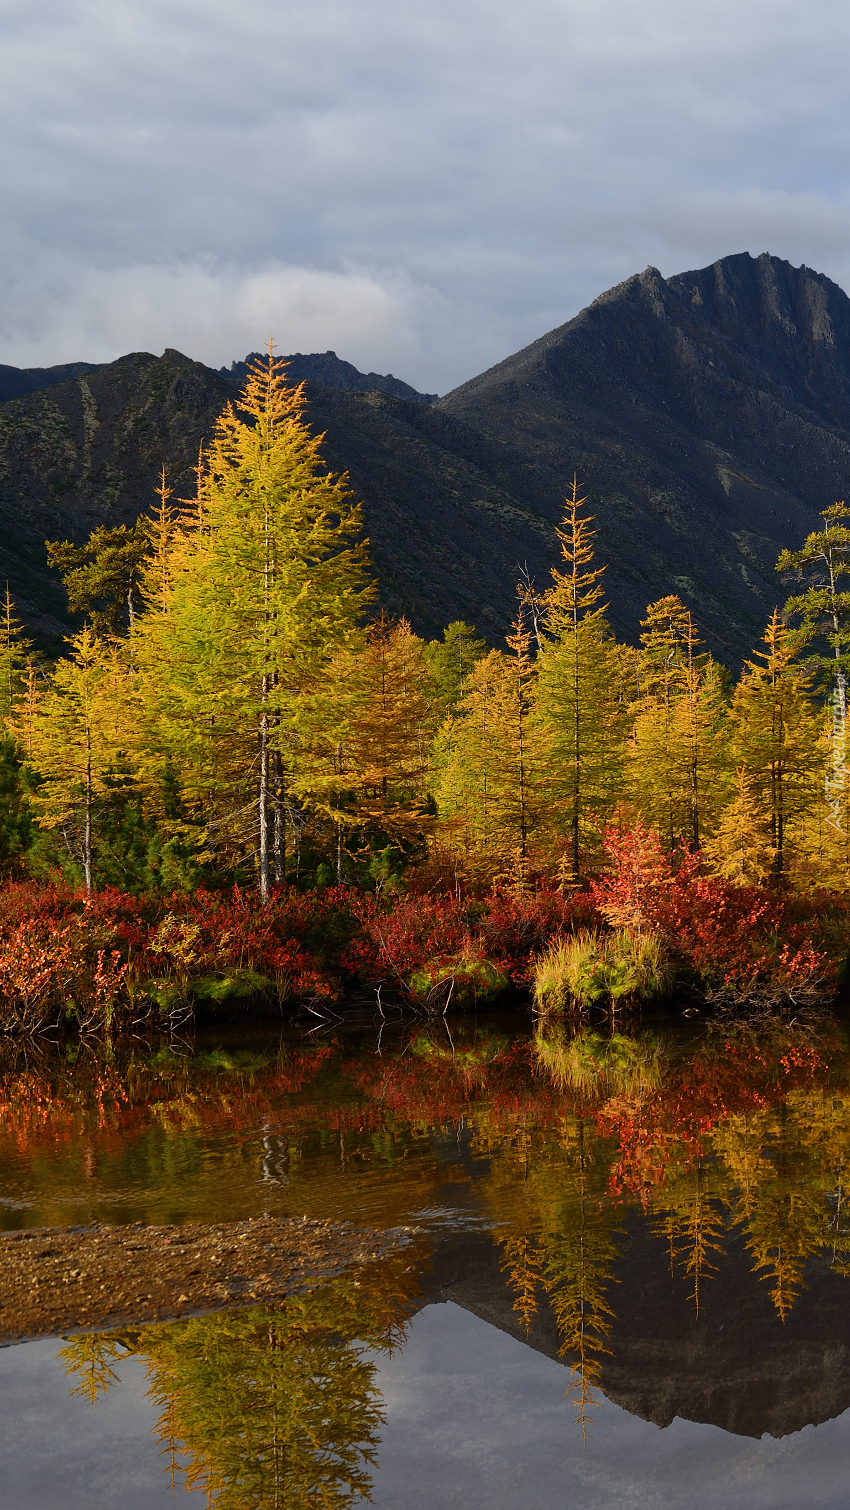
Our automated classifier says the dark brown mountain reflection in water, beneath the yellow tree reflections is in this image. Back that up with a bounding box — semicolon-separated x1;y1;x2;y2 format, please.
427;1219;850;1438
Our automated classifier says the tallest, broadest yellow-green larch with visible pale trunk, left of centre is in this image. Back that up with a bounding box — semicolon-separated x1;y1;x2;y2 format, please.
132;355;371;901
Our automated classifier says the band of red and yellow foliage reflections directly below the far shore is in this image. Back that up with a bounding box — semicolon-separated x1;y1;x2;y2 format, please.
16;1018;850;1437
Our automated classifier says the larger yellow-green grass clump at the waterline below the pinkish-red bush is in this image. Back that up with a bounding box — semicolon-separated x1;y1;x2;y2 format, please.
533;929;673;1015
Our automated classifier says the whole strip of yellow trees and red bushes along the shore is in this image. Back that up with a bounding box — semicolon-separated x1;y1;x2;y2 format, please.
0;355;850;1034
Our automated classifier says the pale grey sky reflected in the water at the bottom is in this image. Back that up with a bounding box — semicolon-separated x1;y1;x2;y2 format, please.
0;1303;850;1510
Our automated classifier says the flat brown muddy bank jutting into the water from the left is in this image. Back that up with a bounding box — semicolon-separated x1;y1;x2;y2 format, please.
0;1217;412;1344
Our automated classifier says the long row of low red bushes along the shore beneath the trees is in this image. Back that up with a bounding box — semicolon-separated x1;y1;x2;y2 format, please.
0;824;847;1030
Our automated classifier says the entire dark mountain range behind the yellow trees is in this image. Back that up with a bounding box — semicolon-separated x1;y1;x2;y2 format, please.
0;254;850;664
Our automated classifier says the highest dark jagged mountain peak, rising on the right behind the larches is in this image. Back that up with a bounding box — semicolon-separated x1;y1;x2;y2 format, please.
439;254;850;655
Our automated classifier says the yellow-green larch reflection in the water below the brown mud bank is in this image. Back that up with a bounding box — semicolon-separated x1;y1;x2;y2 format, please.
59;1250;414;1510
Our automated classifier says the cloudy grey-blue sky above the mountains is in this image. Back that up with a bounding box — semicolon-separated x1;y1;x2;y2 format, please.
0;0;850;393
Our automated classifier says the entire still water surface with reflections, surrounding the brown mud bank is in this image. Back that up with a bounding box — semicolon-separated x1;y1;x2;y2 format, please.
0;1016;850;1510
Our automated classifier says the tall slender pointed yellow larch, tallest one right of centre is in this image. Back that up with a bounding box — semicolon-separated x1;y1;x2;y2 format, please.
537;477;625;882
